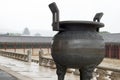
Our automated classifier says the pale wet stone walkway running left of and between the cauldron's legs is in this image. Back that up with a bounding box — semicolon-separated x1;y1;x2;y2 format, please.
0;56;79;80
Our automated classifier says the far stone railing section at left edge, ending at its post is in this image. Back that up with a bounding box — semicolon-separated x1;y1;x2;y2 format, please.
0;51;31;62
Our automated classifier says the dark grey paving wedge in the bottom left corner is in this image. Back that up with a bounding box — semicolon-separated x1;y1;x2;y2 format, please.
0;70;18;80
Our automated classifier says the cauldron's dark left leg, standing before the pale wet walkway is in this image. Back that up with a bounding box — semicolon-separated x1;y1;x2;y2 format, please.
56;64;67;80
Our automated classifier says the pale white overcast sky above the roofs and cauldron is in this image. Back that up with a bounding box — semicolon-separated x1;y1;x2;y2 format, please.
0;0;120;36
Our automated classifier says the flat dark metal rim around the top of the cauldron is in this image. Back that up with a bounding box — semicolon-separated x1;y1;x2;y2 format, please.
59;20;104;28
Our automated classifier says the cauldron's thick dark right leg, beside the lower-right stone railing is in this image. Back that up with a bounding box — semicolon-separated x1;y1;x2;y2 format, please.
79;65;95;80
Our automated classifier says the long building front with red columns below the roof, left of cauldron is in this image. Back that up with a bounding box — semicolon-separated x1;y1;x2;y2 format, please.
0;43;51;56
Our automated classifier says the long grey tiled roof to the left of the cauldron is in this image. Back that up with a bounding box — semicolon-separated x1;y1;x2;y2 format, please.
0;35;52;43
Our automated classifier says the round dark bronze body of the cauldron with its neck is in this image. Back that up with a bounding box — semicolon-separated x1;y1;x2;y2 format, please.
52;22;104;68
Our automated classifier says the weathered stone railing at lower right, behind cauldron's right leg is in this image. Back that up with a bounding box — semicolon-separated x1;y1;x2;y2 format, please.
73;67;120;80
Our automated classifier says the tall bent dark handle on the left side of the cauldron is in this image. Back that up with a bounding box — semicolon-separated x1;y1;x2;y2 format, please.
49;2;59;31
